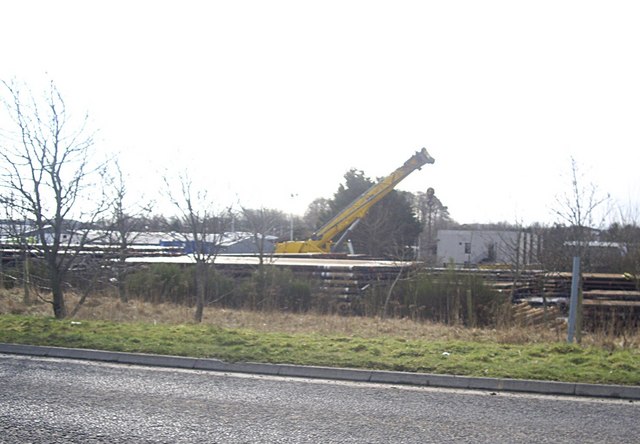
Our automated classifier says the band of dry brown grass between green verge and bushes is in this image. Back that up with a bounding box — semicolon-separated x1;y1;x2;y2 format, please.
0;290;640;349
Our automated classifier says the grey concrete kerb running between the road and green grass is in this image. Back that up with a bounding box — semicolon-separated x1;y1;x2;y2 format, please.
0;343;640;400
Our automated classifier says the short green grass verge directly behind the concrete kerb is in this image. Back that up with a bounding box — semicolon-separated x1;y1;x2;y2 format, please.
0;314;640;385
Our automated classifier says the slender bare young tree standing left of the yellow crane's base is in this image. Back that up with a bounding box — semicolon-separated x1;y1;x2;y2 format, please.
164;172;228;322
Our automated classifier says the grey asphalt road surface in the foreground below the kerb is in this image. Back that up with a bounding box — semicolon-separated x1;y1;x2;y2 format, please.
0;355;640;443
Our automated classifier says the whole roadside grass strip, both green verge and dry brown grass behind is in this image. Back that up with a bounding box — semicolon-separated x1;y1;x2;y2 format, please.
0;294;640;385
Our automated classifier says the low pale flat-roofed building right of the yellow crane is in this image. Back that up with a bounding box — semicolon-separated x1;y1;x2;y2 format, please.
436;230;539;267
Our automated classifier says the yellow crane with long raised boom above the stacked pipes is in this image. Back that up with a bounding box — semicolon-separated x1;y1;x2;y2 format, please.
275;148;435;254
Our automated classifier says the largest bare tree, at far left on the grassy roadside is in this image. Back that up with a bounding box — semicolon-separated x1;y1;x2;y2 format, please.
0;81;104;318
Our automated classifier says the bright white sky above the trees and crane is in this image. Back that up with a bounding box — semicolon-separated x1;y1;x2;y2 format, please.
0;0;640;223
